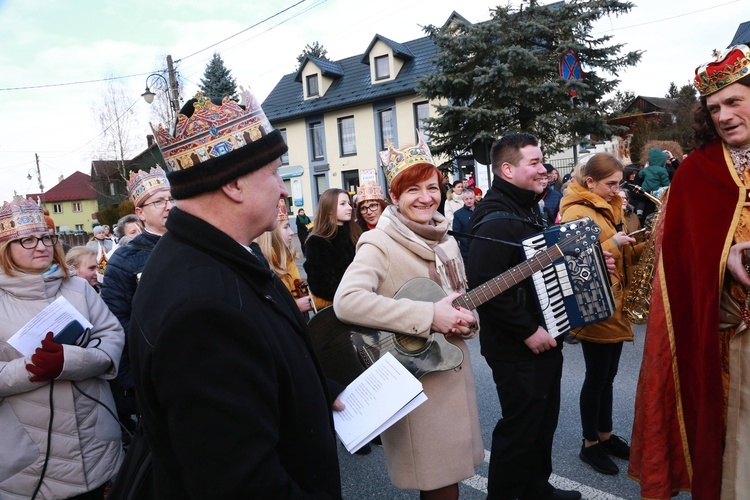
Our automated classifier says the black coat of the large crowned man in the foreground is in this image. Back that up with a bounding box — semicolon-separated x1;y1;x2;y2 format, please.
129;208;341;499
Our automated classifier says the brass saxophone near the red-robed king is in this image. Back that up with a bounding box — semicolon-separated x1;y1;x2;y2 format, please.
622;185;662;325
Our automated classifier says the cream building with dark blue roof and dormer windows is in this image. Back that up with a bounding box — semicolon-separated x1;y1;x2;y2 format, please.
262;13;460;213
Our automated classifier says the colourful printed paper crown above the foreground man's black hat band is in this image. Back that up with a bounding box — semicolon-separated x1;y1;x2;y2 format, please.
151;91;273;172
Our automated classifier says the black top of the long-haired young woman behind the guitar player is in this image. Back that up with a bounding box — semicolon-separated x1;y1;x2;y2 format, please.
304;224;355;301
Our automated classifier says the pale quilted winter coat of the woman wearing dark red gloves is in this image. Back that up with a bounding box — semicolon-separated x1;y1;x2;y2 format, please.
0;270;125;500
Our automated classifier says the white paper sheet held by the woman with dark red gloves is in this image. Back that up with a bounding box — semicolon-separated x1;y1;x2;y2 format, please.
8;296;93;356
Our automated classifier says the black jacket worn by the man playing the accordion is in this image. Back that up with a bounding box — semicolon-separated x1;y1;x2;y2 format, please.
467;177;562;361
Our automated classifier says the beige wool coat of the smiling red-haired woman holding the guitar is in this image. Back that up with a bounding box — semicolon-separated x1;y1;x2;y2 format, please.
334;209;484;490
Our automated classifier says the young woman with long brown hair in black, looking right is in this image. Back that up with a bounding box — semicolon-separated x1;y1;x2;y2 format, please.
304;189;362;310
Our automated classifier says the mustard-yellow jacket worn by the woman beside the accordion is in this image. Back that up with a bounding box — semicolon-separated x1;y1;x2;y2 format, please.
560;184;637;344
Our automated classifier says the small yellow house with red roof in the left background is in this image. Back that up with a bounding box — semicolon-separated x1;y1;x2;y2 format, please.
44;172;99;232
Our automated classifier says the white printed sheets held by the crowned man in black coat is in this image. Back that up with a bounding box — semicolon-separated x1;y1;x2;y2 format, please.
333;353;427;453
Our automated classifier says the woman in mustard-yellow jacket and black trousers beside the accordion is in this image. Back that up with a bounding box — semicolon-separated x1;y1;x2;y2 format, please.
560;153;637;474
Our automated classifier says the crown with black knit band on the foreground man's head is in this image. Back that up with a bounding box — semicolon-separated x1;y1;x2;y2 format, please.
151;91;288;200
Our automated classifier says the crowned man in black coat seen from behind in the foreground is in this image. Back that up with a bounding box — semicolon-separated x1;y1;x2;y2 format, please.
129;94;341;499
